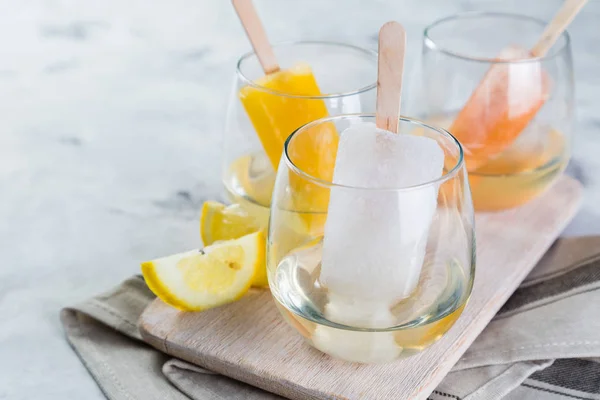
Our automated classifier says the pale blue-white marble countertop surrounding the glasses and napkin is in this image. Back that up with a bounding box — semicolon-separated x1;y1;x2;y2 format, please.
0;0;600;399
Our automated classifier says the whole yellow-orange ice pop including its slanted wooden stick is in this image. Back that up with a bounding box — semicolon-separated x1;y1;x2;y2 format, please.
233;0;338;230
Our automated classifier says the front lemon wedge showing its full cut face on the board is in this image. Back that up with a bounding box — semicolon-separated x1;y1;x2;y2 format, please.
142;231;265;311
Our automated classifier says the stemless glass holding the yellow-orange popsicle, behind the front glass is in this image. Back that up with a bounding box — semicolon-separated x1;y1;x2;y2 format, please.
222;42;377;227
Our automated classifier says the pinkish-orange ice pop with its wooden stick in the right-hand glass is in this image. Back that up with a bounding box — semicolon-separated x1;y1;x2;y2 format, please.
450;0;587;171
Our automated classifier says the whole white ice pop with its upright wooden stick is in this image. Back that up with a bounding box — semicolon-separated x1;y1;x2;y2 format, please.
312;22;444;362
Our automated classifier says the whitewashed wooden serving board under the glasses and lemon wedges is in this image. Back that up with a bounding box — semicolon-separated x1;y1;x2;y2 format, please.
140;176;582;400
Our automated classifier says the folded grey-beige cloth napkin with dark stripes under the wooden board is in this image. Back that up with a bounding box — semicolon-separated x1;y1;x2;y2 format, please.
61;237;600;400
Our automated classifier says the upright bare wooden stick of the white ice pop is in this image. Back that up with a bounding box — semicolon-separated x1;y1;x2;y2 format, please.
375;21;406;133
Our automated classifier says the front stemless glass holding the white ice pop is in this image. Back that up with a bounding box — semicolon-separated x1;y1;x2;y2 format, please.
267;114;475;363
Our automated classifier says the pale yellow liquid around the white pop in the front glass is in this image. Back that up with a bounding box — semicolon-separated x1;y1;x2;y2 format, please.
269;245;472;361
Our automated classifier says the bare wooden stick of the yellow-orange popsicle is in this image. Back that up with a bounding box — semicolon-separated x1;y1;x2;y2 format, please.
231;0;279;75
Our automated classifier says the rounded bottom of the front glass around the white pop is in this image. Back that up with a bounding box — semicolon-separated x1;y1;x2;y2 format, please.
270;245;472;363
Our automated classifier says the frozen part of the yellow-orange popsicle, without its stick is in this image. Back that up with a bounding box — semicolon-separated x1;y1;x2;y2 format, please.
239;64;338;234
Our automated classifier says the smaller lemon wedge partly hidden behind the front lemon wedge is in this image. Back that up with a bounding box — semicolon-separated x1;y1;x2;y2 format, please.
200;201;261;246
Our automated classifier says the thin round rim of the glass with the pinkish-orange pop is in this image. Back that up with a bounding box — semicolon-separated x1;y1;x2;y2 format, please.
423;11;571;64
